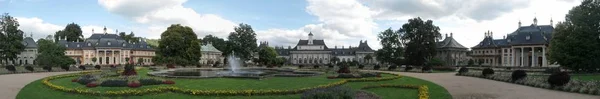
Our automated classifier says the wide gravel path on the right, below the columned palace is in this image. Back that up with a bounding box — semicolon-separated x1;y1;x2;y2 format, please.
364;72;600;99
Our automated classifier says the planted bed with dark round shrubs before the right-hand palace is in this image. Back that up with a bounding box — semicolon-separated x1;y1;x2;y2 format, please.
456;72;600;95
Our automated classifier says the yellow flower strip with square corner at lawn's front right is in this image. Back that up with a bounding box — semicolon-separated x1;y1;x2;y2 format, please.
361;84;429;99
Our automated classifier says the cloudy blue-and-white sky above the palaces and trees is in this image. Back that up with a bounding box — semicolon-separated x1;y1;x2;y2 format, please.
0;0;581;49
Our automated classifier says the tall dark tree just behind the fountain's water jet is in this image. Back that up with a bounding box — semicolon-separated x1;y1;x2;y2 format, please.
227;23;258;61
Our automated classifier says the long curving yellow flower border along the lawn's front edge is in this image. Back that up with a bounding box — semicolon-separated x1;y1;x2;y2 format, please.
42;71;400;96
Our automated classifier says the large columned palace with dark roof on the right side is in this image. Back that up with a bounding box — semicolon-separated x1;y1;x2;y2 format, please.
471;18;554;67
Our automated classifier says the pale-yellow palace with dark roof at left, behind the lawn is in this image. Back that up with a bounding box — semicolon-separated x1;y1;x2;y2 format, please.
57;27;155;65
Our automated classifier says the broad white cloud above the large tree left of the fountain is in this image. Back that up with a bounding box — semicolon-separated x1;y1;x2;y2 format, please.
98;0;236;37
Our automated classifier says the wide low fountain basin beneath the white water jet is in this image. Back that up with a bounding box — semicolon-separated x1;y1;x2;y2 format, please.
148;68;322;79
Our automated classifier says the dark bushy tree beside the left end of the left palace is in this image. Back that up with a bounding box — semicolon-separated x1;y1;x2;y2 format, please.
35;39;75;67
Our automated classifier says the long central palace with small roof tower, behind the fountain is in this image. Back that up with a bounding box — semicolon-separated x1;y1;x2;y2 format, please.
259;32;377;65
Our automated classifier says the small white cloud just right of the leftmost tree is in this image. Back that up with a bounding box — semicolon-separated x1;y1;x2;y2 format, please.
15;17;64;40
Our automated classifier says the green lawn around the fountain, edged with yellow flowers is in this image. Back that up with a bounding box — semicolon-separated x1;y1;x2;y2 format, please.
17;69;451;99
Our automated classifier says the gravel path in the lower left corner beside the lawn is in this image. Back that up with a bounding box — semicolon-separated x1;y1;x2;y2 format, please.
0;72;74;99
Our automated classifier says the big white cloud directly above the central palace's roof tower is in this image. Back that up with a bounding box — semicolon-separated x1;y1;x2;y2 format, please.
257;0;379;48
